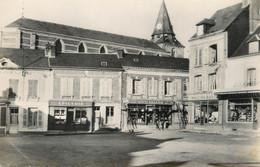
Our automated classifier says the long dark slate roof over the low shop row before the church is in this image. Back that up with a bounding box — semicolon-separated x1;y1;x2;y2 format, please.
0;48;189;71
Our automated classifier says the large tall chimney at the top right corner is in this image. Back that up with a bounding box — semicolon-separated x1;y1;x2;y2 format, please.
249;0;260;34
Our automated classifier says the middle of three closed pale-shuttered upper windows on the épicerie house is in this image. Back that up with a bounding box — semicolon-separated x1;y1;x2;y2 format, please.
80;78;93;98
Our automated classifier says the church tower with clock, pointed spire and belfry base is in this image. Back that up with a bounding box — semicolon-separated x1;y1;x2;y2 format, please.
152;0;184;58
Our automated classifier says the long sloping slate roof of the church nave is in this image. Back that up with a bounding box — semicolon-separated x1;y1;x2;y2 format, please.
6;18;165;52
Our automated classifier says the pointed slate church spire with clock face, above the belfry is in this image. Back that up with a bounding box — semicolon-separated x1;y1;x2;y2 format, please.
152;0;175;36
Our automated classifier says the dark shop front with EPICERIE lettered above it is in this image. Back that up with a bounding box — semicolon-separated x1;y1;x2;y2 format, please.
48;100;93;132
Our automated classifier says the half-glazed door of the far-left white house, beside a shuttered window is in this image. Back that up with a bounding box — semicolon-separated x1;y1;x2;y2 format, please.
9;107;19;133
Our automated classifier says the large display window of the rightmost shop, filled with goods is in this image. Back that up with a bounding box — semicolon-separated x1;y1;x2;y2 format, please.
228;99;252;122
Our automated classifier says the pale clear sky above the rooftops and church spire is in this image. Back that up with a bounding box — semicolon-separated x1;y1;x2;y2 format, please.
0;0;242;57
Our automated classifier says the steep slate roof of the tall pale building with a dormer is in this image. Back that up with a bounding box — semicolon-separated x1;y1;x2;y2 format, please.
191;3;247;39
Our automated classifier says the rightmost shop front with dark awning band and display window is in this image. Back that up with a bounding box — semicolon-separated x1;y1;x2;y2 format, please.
218;92;260;130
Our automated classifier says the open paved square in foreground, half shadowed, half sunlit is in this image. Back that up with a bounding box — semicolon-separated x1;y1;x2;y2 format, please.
0;130;260;167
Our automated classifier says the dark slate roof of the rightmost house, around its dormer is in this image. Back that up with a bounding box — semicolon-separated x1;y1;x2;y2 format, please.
230;26;260;57
